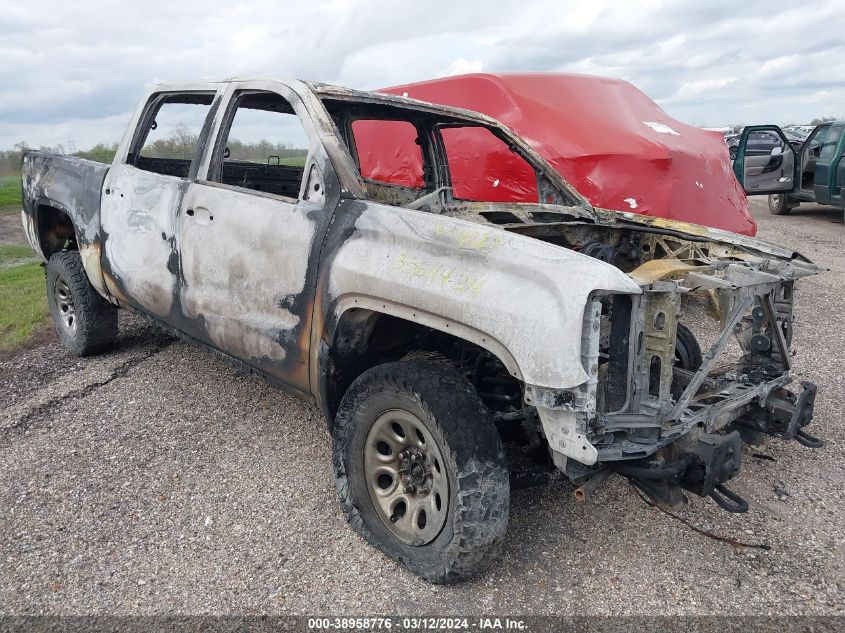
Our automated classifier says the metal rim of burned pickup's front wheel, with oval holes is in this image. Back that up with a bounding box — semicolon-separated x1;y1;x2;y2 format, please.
363;409;449;546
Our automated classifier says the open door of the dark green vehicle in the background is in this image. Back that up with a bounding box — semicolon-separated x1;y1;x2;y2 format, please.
733;125;797;196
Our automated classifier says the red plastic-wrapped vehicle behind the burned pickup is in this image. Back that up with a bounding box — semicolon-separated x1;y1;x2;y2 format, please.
380;73;757;235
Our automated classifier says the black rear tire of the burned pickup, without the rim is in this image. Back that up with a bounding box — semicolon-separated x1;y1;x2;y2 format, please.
46;251;117;356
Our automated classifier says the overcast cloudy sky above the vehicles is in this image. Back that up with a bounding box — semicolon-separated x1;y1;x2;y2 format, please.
0;0;845;149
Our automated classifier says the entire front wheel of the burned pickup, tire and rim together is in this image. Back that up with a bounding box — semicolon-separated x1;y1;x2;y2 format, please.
333;360;510;583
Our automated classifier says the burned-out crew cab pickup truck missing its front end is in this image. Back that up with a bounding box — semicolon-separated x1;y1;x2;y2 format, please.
23;80;820;582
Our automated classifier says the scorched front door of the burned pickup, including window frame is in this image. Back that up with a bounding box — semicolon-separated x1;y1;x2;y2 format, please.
179;82;339;393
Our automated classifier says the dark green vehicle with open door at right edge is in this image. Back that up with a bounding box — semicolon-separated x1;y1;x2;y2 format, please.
733;121;845;220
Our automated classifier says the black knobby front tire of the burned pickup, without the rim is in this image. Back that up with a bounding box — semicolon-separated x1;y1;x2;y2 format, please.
333;358;510;583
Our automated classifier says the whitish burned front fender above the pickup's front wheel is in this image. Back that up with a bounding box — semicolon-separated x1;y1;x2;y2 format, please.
323;203;641;389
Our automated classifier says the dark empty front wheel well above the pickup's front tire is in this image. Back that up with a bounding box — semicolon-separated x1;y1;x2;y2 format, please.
325;308;523;420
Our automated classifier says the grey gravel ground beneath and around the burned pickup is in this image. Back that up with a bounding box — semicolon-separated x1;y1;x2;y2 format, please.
0;202;845;615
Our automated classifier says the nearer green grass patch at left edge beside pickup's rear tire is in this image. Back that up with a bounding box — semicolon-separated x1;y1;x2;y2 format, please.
0;245;50;351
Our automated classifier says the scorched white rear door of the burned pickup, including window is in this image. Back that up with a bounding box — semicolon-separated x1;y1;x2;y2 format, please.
100;89;216;318
